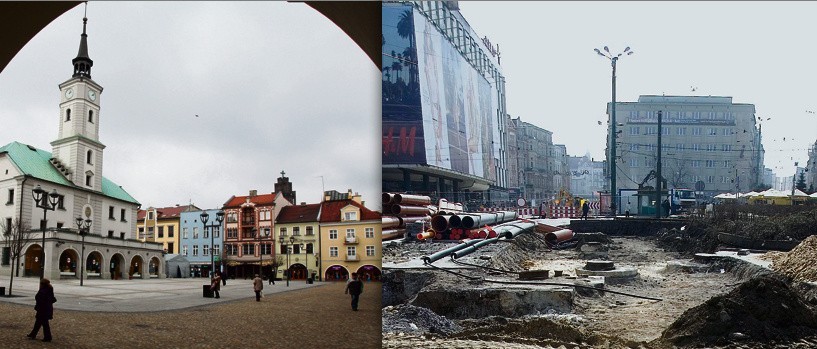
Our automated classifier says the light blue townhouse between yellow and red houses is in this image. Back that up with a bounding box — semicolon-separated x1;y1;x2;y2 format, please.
178;209;224;277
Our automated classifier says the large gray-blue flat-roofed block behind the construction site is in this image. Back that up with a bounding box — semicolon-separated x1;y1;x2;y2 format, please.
608;96;764;196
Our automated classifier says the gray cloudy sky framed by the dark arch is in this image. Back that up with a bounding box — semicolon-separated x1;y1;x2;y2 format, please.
0;2;380;209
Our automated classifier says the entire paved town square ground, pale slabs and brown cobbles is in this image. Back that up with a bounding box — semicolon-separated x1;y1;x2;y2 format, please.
0;275;382;349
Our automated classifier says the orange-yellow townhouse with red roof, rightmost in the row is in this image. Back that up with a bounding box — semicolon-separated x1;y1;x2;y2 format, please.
318;190;382;281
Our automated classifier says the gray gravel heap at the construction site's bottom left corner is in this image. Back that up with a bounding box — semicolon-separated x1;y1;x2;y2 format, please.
381;304;462;336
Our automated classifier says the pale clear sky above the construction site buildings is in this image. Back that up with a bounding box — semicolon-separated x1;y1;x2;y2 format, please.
459;1;817;177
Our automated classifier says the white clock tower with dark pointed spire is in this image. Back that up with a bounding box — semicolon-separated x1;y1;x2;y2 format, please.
51;14;105;192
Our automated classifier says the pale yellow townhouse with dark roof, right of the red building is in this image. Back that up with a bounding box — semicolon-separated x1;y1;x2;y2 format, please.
275;203;322;280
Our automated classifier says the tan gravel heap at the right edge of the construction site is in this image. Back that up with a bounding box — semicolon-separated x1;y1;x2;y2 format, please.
770;235;817;282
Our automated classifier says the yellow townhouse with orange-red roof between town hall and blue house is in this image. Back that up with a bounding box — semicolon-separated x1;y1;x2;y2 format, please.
136;204;200;253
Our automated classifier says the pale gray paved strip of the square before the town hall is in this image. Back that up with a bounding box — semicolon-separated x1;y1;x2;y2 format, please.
0;275;325;312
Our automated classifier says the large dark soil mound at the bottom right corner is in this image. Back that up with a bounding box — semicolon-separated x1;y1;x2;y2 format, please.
653;275;817;347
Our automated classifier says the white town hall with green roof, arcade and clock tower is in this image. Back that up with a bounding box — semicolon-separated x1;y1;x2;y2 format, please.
0;14;165;279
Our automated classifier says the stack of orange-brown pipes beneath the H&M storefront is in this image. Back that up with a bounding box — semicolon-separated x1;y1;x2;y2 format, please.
381;193;436;240
